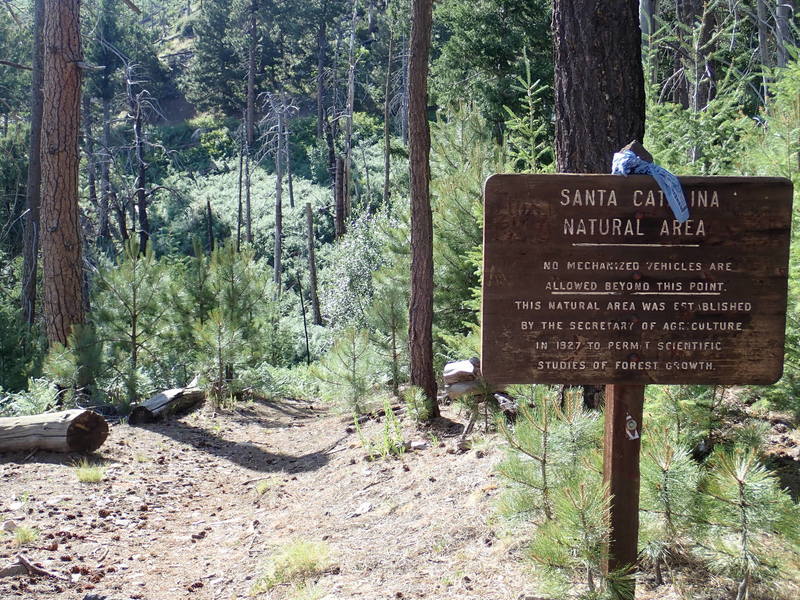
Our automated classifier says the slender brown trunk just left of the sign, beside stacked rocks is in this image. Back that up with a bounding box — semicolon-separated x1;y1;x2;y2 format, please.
408;0;439;418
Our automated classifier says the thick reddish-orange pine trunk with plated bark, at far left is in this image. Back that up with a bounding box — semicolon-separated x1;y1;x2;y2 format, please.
41;0;85;345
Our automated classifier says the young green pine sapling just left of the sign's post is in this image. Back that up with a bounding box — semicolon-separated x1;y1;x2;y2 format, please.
498;385;630;598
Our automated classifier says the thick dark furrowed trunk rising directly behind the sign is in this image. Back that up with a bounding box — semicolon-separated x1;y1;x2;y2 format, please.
553;0;644;173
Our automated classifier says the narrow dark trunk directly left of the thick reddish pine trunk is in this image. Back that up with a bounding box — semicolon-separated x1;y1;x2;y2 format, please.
20;0;44;325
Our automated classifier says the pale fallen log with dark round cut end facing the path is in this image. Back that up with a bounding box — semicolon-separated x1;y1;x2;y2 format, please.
0;408;108;452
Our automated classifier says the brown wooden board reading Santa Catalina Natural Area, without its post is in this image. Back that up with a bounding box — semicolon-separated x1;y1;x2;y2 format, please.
481;175;792;385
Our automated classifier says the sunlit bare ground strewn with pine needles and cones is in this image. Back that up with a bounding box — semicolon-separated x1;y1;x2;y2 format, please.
0;400;796;600
